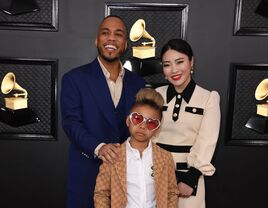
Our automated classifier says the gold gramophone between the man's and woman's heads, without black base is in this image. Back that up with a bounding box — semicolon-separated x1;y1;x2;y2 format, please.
129;19;156;59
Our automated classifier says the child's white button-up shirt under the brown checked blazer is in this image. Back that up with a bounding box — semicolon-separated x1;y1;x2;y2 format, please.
126;138;156;208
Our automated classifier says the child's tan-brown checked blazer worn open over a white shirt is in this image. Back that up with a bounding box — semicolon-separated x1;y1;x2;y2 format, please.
94;142;178;208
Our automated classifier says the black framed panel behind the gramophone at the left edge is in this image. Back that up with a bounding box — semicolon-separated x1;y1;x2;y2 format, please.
0;58;57;140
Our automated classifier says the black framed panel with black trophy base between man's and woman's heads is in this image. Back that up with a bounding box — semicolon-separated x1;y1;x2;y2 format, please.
106;3;188;87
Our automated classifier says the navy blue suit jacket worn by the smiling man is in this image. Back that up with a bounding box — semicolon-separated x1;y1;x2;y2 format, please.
61;59;145;207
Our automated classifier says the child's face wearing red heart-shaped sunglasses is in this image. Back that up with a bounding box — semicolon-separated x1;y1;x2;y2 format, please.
126;105;161;143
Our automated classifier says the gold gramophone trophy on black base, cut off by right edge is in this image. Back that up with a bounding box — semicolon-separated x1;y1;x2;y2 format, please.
245;78;268;134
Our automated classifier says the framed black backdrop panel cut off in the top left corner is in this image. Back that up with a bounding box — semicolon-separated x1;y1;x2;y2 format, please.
0;0;58;31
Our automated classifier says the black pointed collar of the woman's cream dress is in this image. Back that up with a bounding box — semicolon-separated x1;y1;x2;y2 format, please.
167;79;196;103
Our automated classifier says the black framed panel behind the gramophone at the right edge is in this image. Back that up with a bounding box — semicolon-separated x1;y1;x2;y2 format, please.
226;64;268;145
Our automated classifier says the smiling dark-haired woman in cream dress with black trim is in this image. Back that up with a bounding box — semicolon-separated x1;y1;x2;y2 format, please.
155;39;220;208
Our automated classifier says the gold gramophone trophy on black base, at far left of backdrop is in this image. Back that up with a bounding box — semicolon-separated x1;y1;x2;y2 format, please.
0;72;40;127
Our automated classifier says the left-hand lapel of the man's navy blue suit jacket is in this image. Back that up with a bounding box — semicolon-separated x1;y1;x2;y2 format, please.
88;59;116;129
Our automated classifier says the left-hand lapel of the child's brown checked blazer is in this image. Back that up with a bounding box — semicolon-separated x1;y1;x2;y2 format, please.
115;142;127;194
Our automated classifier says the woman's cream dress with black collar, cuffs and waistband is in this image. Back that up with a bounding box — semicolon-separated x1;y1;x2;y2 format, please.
154;80;221;208
